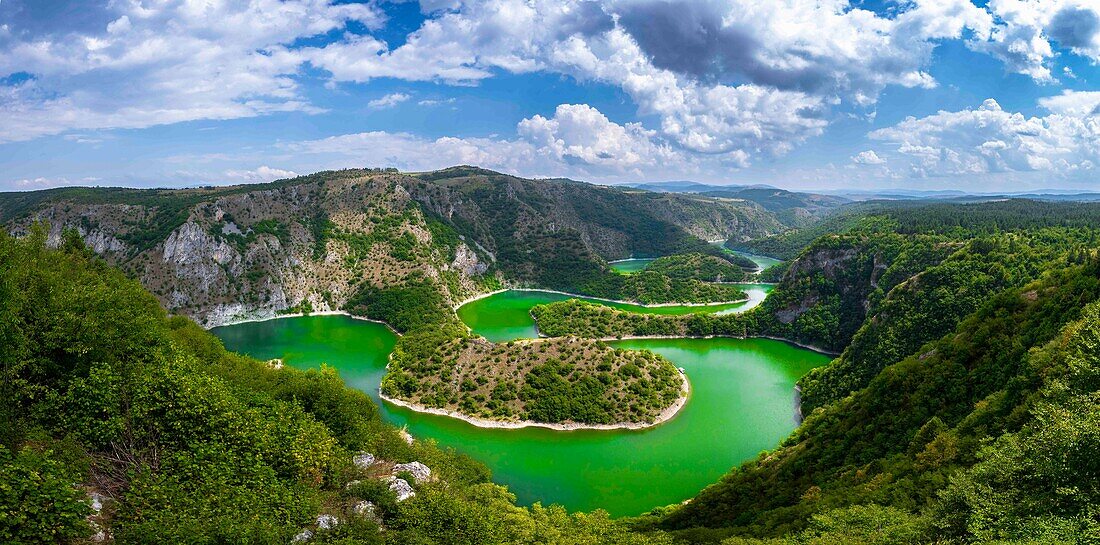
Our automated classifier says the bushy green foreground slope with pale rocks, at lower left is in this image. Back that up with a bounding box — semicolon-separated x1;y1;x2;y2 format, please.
0;224;704;545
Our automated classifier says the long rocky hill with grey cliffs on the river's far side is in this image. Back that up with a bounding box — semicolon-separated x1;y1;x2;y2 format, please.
0;167;783;325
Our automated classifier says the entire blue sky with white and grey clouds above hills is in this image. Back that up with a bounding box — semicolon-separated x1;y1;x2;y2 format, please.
0;0;1100;192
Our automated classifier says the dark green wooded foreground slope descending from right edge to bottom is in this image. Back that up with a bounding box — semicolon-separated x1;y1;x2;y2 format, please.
663;258;1100;543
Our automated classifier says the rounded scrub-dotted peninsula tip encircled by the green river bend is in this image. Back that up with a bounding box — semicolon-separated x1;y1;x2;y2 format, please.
382;338;682;424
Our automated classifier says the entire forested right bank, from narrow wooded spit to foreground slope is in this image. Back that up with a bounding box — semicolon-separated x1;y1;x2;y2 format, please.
523;200;1100;545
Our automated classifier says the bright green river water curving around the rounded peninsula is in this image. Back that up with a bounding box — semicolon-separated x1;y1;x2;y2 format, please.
213;255;828;515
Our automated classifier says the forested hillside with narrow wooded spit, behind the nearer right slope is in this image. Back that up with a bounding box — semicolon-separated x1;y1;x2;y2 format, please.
536;203;1100;412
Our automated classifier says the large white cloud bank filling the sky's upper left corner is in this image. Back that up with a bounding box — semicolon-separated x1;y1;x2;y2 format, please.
0;0;382;142
